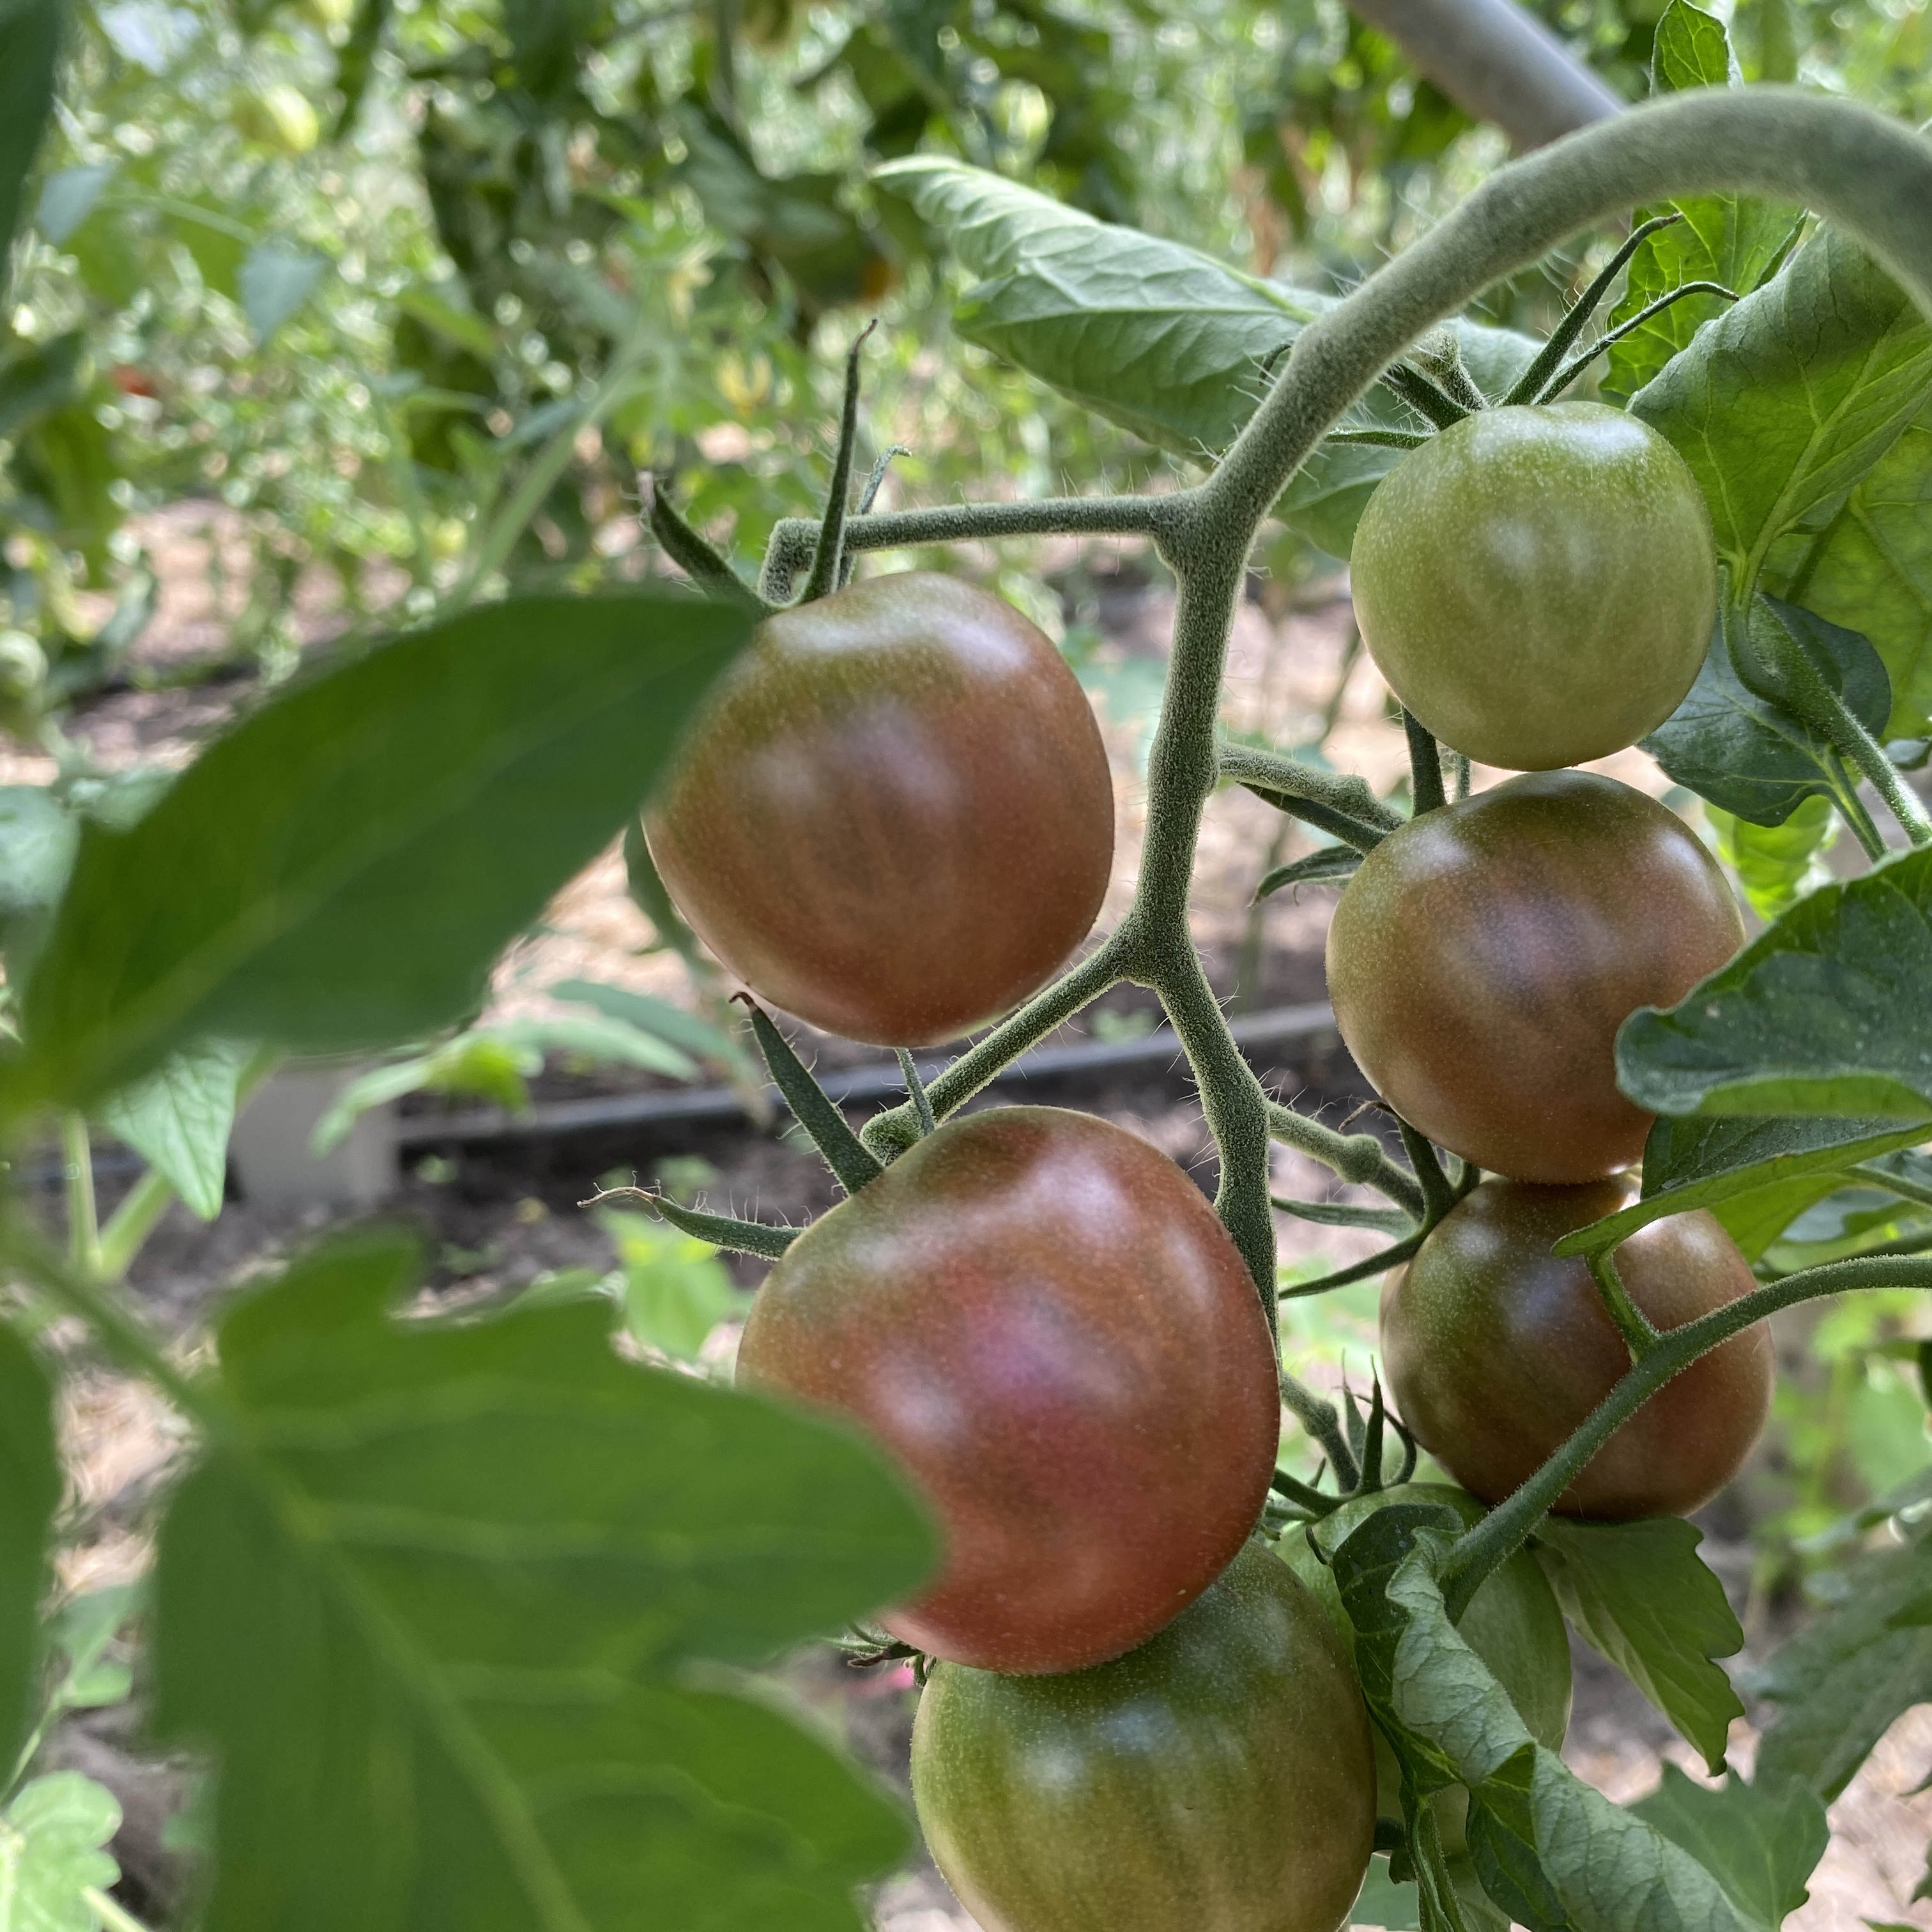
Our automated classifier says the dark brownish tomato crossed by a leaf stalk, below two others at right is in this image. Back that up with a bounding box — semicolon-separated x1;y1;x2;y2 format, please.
1381;1179;1774;1522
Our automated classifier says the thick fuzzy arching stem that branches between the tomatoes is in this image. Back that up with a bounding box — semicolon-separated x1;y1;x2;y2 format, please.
803;87;1932;1499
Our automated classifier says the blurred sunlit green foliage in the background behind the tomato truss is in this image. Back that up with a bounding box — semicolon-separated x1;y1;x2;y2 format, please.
0;0;1932;1583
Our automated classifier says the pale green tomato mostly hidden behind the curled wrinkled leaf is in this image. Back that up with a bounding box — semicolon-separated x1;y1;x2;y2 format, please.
1277;1482;1571;1855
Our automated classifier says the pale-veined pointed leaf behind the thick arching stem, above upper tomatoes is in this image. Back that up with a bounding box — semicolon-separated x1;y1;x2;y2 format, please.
873;155;1538;556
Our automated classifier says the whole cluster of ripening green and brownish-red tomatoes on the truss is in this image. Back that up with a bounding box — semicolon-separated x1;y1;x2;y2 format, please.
647;395;1768;1932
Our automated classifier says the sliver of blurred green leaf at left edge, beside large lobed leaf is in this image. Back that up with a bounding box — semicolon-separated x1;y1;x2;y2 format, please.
0;1321;60;1770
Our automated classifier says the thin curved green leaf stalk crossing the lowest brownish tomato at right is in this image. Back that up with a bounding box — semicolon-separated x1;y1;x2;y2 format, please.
1443;1256;1932;1621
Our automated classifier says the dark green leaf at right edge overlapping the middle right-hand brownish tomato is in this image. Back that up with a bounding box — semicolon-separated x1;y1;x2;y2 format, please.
1617;847;1932;1138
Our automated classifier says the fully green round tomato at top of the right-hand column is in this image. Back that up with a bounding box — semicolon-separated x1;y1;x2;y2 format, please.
1351;402;1717;771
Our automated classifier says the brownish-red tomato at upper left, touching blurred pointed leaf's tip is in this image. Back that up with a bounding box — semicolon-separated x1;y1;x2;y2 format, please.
645;572;1113;1047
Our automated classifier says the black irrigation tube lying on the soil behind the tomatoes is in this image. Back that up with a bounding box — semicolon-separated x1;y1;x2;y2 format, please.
396;1000;1335;1149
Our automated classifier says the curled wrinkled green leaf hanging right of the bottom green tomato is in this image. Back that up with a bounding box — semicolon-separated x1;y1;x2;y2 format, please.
1335;1503;1752;1932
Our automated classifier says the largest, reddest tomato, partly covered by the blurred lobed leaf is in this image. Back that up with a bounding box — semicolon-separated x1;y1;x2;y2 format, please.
738;1107;1281;1671
